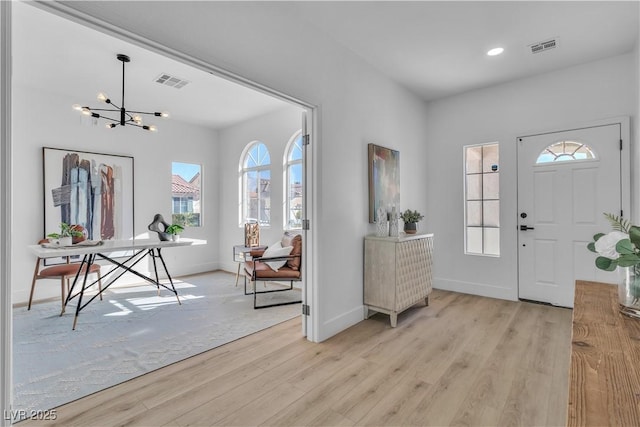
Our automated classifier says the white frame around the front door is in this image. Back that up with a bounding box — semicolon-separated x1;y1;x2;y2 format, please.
515;116;640;302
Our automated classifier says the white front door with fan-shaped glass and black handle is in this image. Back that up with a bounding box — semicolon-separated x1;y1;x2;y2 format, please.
517;124;622;307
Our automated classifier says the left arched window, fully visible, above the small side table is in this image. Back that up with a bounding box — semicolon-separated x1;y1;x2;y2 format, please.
240;141;271;226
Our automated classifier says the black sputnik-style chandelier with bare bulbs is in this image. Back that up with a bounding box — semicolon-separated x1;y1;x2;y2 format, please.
73;53;169;132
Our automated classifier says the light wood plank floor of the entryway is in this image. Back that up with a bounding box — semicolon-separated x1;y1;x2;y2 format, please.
20;290;571;426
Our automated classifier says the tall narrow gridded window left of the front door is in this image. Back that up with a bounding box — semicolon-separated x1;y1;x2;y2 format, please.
464;143;500;256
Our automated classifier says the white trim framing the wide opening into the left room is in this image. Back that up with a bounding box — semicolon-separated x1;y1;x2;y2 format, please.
0;0;319;426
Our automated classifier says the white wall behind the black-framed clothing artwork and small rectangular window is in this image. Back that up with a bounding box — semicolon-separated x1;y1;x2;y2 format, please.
11;84;219;304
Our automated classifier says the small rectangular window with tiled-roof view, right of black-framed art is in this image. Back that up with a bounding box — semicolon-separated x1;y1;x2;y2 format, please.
171;162;202;227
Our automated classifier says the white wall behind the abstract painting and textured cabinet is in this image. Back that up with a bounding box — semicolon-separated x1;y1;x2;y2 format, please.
55;2;429;340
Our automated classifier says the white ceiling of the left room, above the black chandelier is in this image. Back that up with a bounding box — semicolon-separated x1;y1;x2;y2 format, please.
12;2;290;129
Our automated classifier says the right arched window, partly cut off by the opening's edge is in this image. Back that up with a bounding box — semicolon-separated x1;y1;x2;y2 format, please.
283;130;304;230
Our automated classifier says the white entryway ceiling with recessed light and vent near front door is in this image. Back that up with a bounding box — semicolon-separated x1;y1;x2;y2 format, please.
292;1;639;100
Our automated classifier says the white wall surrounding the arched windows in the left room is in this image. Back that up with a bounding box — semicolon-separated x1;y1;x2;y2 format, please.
218;106;302;273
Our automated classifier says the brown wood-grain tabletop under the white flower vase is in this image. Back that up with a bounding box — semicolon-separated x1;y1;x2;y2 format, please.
567;280;640;426
